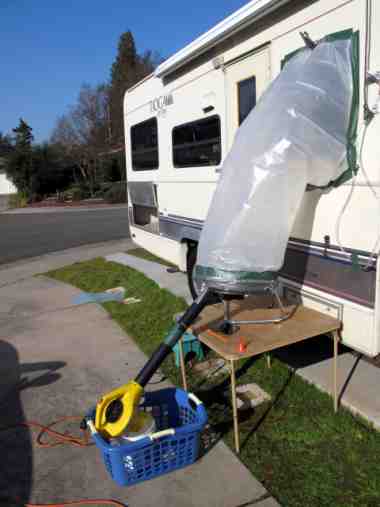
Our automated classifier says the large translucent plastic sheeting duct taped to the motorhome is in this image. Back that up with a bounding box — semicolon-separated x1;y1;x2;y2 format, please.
196;33;356;294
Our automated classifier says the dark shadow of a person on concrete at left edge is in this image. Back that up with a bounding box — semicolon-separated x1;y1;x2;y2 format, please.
0;340;65;507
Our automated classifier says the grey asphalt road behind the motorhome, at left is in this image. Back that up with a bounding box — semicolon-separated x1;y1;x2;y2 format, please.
0;207;129;264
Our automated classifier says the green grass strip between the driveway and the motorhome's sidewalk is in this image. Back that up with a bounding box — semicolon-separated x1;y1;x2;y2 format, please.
47;259;380;507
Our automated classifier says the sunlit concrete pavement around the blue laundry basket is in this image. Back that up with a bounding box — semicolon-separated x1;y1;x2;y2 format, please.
0;248;278;507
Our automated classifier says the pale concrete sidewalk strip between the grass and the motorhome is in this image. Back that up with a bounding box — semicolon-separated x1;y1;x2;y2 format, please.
106;253;380;430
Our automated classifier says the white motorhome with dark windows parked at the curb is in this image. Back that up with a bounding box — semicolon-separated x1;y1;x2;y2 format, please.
124;0;380;356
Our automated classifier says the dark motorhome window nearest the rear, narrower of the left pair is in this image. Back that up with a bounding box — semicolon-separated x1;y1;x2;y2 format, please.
131;118;158;171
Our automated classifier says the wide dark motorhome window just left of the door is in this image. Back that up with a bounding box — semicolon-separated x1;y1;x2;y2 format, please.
172;116;221;167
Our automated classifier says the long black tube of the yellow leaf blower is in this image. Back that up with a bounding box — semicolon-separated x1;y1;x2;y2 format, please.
135;289;212;387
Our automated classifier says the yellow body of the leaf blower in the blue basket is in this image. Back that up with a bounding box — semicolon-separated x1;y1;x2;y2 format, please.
95;381;144;438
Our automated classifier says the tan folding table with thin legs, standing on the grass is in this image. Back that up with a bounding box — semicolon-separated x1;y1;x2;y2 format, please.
180;299;341;453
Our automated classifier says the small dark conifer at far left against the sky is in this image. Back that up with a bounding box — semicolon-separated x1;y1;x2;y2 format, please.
6;118;33;196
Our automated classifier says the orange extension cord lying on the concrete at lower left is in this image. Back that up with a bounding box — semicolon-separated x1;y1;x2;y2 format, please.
0;416;126;507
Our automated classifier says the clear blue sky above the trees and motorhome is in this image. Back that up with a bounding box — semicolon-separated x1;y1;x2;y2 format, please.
0;0;247;141
